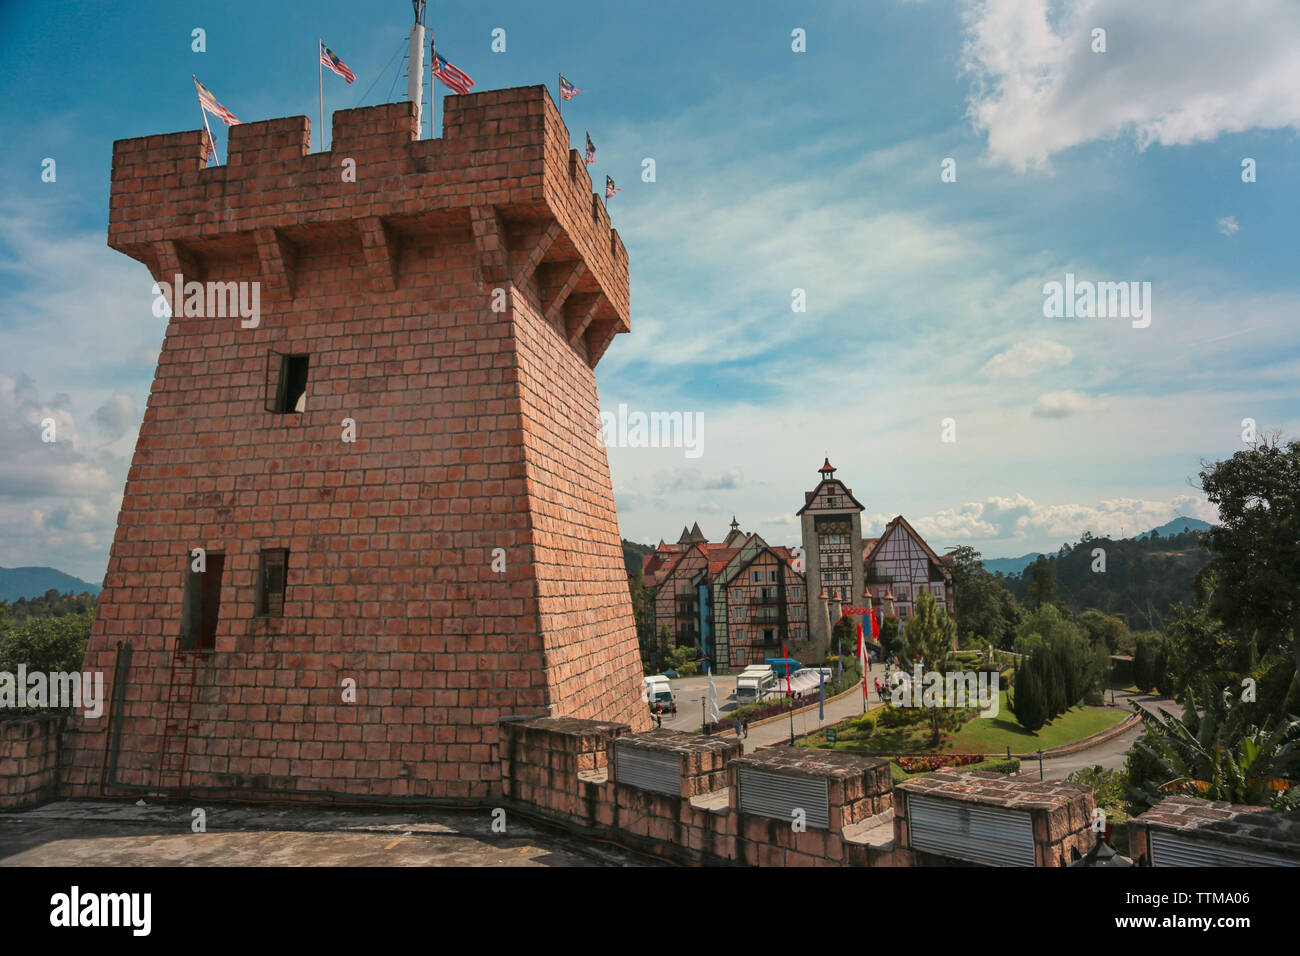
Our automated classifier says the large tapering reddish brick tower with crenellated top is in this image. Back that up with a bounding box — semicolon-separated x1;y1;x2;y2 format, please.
62;86;649;801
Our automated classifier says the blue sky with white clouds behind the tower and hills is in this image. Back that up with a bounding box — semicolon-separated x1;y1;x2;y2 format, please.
0;0;1300;581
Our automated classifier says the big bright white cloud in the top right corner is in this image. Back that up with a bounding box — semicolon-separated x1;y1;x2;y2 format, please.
965;0;1300;170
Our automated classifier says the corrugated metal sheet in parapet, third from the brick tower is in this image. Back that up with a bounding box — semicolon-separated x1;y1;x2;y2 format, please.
907;795;1034;866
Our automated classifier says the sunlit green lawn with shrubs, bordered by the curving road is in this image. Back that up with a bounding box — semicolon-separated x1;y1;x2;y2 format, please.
807;691;1128;753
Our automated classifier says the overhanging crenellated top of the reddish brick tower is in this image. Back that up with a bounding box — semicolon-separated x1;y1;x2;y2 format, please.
108;86;631;367
